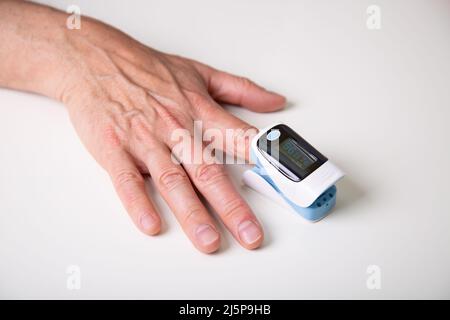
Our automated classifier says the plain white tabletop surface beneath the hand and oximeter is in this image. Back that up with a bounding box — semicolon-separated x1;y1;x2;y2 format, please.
0;0;450;299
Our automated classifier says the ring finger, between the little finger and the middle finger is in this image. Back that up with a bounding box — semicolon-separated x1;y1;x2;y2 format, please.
145;146;220;253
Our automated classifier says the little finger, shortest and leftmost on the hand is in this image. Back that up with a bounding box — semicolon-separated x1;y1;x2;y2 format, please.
107;150;161;235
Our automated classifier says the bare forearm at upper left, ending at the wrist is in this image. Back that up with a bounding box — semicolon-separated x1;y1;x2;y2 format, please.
0;0;68;99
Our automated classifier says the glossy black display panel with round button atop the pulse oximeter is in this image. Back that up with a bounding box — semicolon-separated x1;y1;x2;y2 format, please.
257;124;328;182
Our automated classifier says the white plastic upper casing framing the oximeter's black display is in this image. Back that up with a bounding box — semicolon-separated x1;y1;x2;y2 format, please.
251;124;344;208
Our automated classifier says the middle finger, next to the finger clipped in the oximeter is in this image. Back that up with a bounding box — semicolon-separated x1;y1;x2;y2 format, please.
183;163;264;249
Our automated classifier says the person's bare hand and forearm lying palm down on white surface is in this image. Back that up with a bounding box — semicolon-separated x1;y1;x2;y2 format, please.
0;0;285;253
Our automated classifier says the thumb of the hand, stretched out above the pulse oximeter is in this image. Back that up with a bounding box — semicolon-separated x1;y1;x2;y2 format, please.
196;63;286;112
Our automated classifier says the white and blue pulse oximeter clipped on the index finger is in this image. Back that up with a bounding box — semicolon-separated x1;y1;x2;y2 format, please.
244;124;344;222
